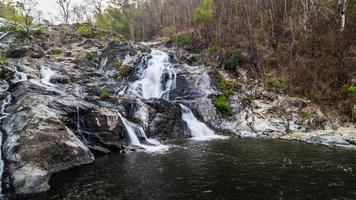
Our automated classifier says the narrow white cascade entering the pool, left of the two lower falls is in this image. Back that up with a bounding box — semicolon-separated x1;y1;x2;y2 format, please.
118;113;168;152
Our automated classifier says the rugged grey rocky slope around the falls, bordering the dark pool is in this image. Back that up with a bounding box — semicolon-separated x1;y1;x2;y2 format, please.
0;26;356;196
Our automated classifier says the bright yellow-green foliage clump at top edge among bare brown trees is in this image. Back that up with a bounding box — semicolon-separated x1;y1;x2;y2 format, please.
193;0;214;23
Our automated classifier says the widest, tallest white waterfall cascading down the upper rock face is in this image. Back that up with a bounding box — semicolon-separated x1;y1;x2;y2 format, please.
128;49;176;100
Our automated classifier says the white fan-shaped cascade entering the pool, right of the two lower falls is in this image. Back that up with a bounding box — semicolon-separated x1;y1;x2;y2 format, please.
180;104;226;140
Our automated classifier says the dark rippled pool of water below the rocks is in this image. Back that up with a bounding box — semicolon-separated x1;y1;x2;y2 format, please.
31;139;356;200
